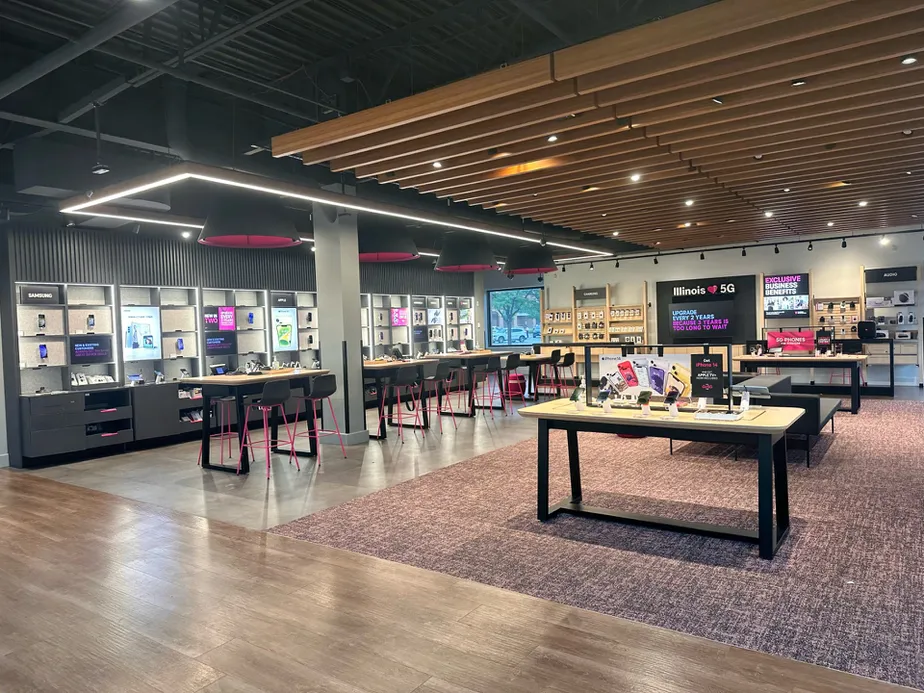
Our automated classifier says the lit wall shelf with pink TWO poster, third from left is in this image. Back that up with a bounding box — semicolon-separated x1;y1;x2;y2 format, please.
202;289;272;369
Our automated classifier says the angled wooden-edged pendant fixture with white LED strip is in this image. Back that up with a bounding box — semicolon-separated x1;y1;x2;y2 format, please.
60;163;611;257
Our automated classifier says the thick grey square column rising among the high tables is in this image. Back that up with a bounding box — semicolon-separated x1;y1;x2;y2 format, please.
313;185;369;445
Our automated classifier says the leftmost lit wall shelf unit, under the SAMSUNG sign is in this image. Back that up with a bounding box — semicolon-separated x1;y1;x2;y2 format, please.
16;283;119;395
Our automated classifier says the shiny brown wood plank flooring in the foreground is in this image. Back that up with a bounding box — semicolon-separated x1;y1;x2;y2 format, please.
0;470;907;693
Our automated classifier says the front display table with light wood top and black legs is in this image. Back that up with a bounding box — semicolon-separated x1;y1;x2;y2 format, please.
520;399;805;559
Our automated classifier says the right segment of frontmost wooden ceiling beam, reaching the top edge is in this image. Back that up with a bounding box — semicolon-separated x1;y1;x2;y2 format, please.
555;0;850;85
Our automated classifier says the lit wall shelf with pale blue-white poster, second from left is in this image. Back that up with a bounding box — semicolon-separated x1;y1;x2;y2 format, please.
119;286;202;385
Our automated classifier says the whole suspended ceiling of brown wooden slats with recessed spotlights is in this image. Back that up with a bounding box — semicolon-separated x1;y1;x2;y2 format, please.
273;0;924;250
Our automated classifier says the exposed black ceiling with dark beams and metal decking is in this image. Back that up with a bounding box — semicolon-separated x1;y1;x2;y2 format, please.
0;0;715;252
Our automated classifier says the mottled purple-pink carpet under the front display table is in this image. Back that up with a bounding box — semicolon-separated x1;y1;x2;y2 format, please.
271;401;924;689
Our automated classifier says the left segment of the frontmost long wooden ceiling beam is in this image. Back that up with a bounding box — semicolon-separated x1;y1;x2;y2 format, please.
273;55;560;158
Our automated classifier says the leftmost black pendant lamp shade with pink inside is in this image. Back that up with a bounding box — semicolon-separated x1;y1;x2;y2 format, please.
199;200;302;249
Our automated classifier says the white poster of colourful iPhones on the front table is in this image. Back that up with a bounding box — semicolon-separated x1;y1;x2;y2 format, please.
600;354;693;398
